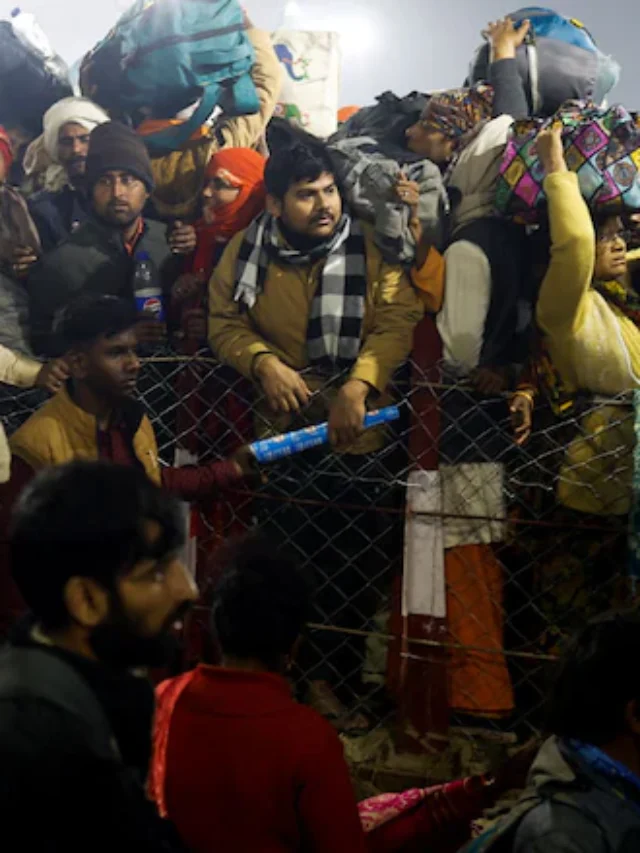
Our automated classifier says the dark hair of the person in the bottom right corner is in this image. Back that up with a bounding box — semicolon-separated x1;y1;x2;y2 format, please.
547;611;640;746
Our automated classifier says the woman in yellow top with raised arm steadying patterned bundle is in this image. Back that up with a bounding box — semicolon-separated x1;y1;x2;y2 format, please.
511;127;640;515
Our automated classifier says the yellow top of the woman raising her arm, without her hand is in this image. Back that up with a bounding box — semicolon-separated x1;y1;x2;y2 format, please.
537;172;640;515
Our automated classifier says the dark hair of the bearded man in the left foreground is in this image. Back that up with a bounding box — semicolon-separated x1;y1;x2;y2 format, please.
9;462;184;629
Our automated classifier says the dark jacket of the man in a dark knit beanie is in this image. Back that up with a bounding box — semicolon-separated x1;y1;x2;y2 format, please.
27;219;181;356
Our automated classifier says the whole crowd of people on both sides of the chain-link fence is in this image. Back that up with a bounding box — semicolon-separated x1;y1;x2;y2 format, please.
0;1;640;853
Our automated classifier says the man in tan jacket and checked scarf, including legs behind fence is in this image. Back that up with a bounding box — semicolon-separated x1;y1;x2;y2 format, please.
209;138;424;729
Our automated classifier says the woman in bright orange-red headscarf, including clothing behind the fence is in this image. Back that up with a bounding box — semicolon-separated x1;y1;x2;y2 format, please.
172;148;266;644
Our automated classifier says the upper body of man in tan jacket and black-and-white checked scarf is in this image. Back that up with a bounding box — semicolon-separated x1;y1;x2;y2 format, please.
209;140;424;451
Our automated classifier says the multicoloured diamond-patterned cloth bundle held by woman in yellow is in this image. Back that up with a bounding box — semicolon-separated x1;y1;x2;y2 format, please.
496;104;640;222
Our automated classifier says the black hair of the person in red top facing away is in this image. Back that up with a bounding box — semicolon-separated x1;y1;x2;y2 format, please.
212;534;311;670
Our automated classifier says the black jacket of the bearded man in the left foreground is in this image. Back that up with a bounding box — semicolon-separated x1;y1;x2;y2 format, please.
0;628;183;853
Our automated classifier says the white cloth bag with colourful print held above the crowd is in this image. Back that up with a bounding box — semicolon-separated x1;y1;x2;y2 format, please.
272;30;340;139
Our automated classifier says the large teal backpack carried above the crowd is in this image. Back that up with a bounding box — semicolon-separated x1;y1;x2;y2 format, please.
81;0;260;150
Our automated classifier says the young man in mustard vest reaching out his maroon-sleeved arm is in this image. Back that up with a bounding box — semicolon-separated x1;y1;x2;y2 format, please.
0;296;252;635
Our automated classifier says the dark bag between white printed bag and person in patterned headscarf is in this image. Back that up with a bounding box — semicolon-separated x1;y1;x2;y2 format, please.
329;92;429;163
